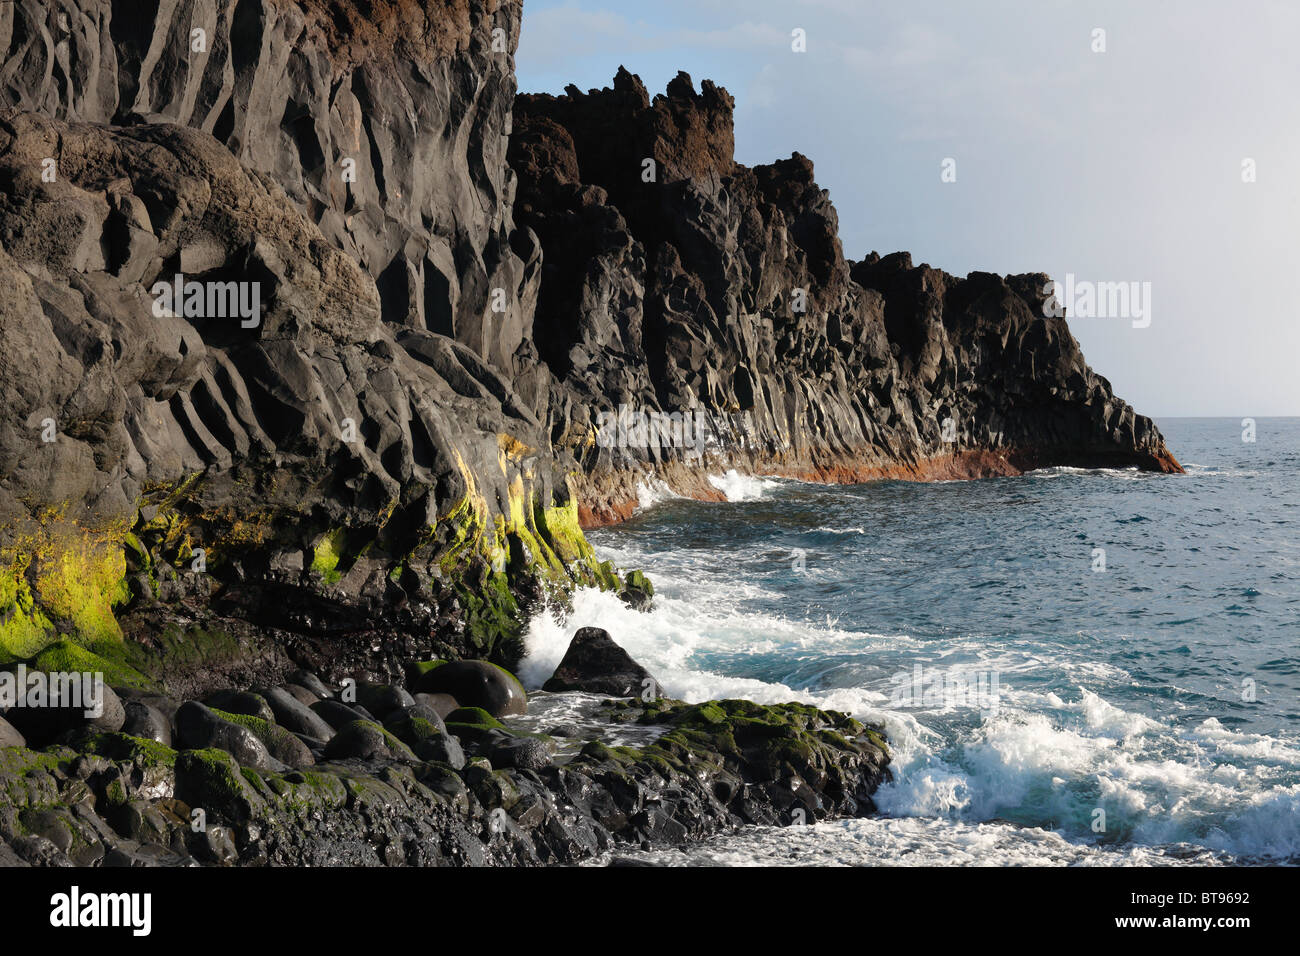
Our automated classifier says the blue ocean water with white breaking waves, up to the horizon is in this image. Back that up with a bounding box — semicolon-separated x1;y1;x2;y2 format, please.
521;419;1300;865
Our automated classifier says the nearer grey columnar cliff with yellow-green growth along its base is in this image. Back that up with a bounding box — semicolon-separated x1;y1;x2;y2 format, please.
0;0;595;680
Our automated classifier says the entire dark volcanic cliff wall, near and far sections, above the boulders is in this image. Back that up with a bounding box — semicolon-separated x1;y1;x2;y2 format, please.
0;0;1178;684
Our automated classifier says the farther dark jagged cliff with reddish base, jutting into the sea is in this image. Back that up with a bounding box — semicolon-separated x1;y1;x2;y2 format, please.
510;72;1179;523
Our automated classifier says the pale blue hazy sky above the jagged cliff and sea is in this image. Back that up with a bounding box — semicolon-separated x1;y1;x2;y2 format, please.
516;0;1300;416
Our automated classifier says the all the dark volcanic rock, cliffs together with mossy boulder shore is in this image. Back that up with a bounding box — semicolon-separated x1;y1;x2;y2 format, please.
0;0;1180;865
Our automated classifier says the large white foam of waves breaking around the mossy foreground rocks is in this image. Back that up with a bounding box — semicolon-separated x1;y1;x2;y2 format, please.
520;549;1300;864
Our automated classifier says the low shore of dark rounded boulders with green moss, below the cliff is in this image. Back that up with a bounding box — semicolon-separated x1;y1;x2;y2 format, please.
0;628;889;866
